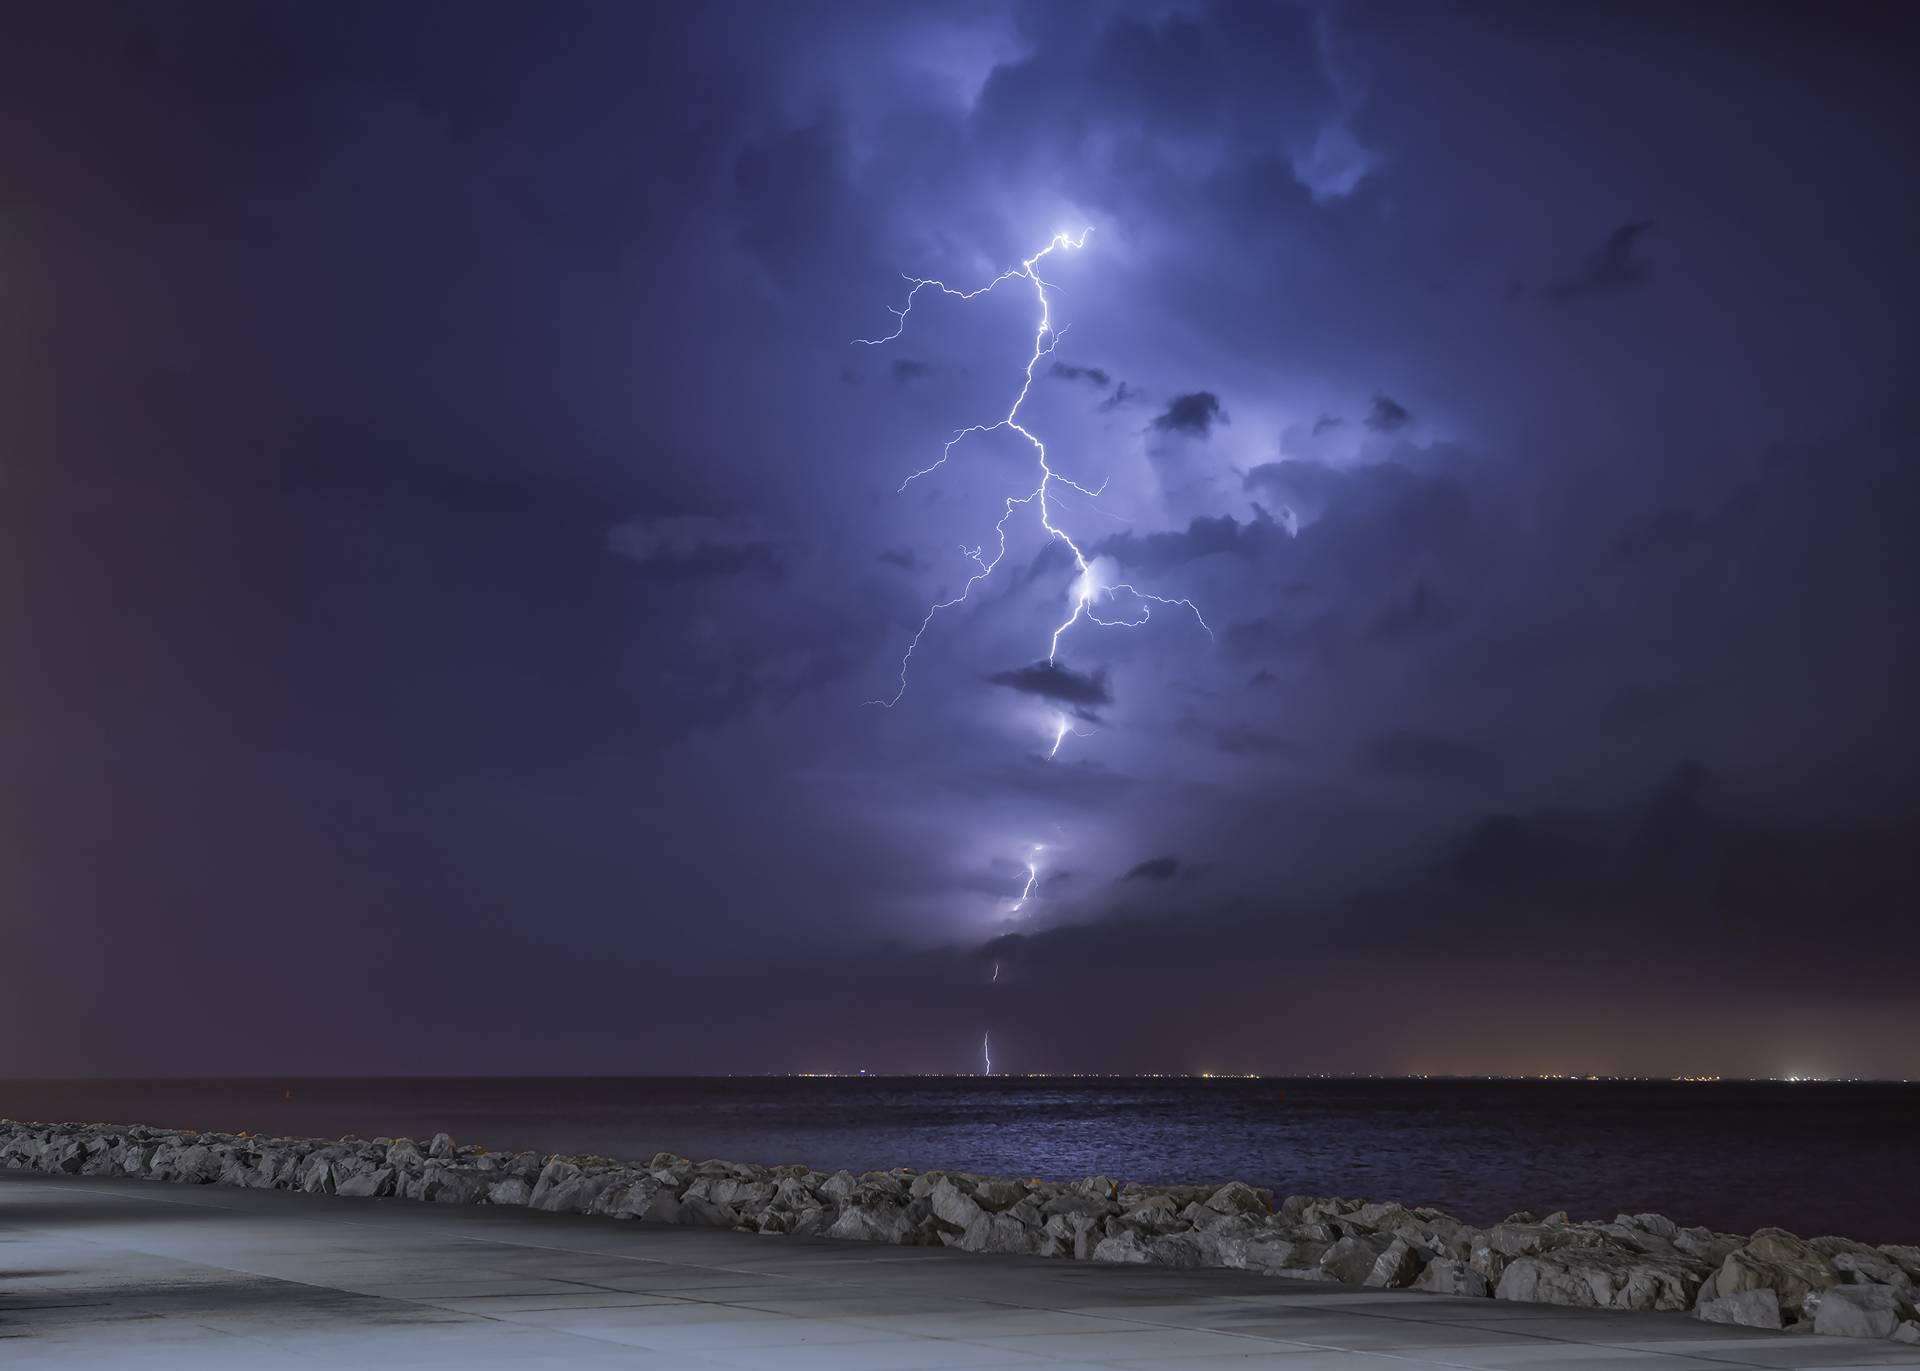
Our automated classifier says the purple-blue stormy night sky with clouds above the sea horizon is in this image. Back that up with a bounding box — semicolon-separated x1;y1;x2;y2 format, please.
0;2;1920;1077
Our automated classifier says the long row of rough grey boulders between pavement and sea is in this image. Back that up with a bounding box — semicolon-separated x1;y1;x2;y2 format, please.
0;1121;1920;1342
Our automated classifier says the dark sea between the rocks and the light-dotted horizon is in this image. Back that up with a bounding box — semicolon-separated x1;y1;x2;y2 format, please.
0;1077;1920;1242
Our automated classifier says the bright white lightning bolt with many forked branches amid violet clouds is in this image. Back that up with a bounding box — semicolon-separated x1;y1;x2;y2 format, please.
854;229;1213;710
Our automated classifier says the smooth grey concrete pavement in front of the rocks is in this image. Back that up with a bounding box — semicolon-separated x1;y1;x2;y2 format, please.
0;1171;1920;1371
